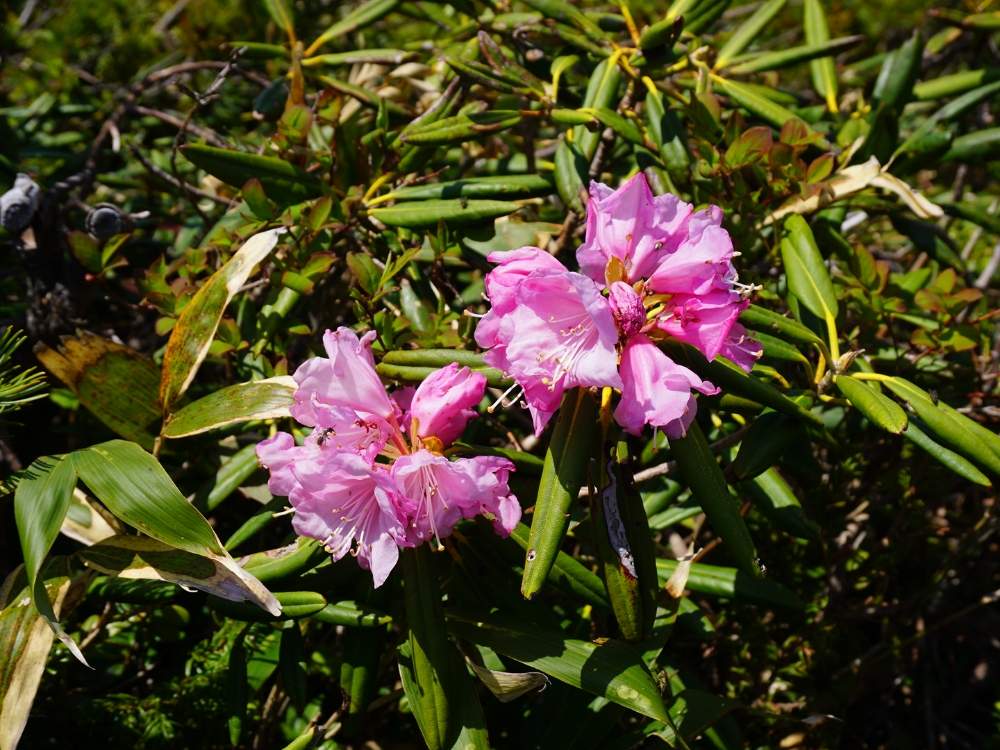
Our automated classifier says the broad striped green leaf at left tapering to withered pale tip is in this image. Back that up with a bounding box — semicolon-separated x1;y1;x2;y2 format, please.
71;440;281;615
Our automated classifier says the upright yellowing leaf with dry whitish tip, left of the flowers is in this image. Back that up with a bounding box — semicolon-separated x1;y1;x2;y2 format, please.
160;229;284;414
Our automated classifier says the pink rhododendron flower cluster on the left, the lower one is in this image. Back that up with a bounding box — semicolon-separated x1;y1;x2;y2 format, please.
257;328;521;587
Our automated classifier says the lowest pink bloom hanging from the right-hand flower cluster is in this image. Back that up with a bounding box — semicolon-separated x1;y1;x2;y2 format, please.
615;334;718;437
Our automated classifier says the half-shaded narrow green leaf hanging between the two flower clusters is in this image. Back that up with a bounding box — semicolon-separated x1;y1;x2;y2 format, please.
521;388;597;599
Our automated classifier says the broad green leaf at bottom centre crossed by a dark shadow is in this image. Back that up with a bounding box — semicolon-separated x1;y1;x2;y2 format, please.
448;614;666;721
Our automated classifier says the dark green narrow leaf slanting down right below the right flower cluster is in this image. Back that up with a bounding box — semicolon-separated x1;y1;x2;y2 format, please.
670;422;760;575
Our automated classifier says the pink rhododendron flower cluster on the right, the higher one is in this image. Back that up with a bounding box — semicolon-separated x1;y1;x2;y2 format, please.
476;172;761;437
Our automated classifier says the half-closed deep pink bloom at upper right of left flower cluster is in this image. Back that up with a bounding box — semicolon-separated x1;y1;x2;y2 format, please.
410;363;486;445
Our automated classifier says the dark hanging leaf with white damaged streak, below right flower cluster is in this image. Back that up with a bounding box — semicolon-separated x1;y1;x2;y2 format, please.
590;443;658;641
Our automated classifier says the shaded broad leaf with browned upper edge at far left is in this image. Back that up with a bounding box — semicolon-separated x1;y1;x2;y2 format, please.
35;331;160;448
